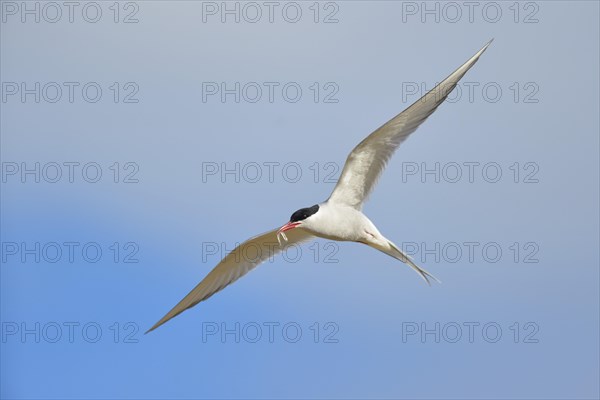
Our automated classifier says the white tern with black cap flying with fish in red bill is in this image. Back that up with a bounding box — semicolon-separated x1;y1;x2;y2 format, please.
146;39;493;333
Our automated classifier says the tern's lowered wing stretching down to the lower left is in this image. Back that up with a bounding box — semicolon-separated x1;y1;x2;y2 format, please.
146;228;313;333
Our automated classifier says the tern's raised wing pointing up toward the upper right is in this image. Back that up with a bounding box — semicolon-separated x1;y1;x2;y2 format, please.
329;39;493;210
